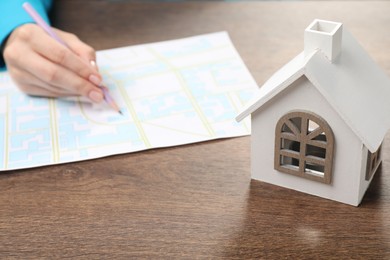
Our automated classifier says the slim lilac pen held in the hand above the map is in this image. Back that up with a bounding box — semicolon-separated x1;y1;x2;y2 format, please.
23;2;122;114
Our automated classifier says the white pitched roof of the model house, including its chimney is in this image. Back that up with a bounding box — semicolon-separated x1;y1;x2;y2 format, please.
236;20;390;152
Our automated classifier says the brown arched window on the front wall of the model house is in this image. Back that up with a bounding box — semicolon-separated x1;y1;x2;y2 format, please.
274;111;334;184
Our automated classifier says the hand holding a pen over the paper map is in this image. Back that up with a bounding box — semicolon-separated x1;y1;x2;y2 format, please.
4;24;103;103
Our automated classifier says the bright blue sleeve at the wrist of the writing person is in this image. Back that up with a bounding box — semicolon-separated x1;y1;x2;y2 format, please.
0;0;52;71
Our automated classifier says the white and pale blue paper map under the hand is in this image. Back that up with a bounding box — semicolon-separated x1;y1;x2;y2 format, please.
0;32;257;170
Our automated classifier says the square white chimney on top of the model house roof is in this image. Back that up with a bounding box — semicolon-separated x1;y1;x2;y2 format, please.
304;19;343;62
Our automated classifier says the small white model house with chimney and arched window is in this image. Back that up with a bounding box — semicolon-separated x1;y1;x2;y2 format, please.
236;20;390;206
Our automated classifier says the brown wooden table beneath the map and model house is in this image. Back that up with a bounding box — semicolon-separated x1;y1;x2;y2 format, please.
0;0;390;259
